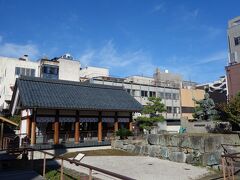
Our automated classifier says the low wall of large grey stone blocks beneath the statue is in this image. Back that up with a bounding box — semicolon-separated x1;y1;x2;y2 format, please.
112;134;240;166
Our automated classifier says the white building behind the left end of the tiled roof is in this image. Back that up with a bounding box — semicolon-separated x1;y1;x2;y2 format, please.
0;54;109;112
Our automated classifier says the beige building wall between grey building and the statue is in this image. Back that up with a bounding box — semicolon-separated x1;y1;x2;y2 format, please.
180;88;205;120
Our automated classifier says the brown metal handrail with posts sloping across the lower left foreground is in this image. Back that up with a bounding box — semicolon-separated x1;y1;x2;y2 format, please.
24;148;134;180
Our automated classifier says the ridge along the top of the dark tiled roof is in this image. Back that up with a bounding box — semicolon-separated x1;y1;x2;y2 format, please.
18;76;123;90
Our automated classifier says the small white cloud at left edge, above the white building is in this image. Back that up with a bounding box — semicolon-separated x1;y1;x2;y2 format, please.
0;36;39;59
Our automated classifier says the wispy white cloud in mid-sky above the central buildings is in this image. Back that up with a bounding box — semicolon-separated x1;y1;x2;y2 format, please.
79;40;156;76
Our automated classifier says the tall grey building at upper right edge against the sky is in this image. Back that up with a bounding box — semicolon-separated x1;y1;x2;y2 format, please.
227;16;240;65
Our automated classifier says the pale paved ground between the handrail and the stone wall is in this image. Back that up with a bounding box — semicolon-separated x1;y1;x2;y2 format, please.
59;156;208;180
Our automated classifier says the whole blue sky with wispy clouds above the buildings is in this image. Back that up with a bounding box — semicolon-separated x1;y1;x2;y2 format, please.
0;0;240;83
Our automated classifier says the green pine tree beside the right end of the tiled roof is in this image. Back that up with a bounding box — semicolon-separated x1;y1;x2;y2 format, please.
137;97;166;133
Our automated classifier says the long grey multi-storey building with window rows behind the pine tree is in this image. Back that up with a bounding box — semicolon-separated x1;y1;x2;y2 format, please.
89;70;181;131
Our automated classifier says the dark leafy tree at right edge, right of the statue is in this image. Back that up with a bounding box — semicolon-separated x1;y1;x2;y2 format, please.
219;92;240;124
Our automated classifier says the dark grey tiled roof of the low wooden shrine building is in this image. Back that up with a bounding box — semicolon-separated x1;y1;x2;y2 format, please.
12;77;142;111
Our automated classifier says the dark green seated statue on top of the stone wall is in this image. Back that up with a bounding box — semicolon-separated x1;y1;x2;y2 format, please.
193;90;217;121
